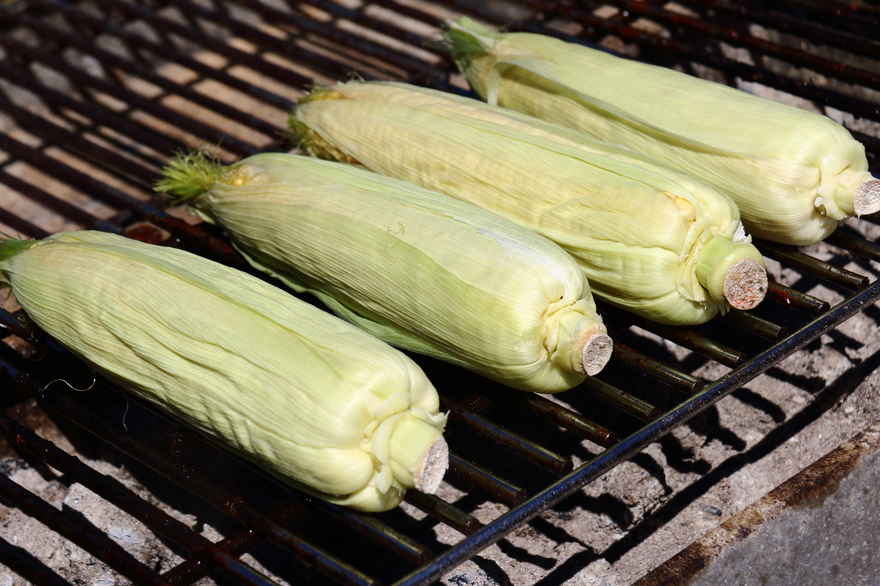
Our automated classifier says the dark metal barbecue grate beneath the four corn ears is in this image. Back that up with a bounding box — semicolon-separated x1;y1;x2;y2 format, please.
0;0;880;585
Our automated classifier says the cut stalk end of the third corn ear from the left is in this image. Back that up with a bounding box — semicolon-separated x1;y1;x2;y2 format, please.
696;236;767;309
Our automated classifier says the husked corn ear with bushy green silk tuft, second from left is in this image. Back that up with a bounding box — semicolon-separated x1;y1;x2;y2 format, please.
158;153;611;392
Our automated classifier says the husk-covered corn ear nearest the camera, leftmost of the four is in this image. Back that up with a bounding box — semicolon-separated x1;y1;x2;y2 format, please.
0;231;447;511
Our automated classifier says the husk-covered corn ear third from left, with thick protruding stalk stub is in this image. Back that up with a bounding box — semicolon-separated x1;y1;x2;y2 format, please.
290;82;766;324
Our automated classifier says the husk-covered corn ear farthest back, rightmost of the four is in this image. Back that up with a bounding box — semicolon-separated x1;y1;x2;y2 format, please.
447;18;880;245
